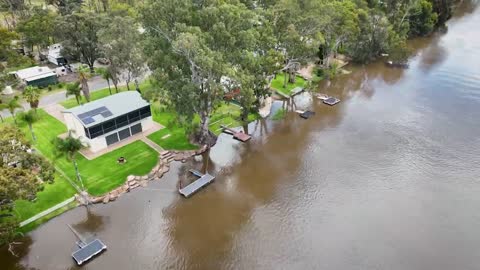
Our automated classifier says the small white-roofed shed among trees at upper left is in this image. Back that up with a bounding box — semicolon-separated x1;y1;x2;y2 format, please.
11;66;58;87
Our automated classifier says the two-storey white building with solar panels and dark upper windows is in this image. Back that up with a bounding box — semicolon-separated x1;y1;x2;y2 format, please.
63;91;153;153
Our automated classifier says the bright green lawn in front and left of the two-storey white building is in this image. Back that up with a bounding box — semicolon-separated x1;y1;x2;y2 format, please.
0;95;158;228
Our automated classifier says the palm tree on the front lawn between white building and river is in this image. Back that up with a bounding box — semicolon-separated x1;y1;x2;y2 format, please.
54;130;85;191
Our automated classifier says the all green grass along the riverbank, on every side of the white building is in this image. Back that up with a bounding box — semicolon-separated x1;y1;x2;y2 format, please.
0;82;258;232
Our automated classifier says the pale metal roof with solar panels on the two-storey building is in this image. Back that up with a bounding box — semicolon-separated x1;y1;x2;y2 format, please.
63;91;149;128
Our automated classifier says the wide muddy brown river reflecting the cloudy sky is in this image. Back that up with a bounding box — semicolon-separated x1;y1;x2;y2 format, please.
0;2;480;270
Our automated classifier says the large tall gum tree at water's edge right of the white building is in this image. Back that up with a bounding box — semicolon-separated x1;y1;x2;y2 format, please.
142;0;256;146
